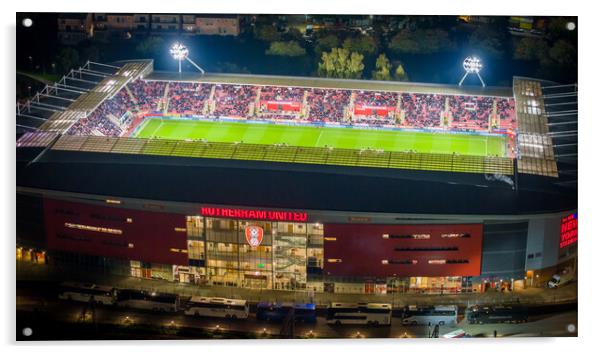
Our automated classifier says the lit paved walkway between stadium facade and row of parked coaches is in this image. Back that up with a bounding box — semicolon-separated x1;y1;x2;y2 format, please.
16;262;577;307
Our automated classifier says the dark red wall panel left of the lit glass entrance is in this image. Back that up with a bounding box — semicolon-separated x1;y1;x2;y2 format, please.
44;199;188;265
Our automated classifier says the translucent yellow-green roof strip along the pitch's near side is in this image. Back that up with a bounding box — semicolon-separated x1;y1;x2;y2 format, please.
47;133;514;175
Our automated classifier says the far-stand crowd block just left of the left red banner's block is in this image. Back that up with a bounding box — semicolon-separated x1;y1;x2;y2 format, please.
213;84;257;118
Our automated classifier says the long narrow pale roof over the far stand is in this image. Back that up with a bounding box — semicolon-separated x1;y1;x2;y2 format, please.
145;71;512;97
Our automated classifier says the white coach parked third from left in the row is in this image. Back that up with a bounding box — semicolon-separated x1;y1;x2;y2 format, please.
184;296;249;319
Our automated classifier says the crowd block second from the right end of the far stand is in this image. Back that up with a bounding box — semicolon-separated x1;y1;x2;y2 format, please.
449;96;493;130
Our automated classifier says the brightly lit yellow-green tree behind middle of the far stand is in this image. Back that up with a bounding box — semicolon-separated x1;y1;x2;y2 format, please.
318;48;364;79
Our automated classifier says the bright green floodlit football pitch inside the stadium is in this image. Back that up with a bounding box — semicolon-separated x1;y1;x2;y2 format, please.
134;118;506;157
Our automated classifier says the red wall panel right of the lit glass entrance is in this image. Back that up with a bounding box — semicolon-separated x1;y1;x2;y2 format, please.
324;224;483;277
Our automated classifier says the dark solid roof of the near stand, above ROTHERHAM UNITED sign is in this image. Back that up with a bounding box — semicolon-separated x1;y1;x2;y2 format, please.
17;148;577;215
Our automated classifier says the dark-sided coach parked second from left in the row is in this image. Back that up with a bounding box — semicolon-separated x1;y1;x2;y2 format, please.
117;289;180;312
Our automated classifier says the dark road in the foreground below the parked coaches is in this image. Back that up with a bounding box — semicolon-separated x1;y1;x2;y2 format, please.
17;283;577;340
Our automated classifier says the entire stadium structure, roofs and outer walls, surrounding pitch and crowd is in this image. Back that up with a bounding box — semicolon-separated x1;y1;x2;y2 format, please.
17;61;577;293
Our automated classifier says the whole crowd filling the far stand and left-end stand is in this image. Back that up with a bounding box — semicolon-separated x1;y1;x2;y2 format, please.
64;80;516;136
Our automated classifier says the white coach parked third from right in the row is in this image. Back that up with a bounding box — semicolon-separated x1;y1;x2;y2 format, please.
326;302;393;326
